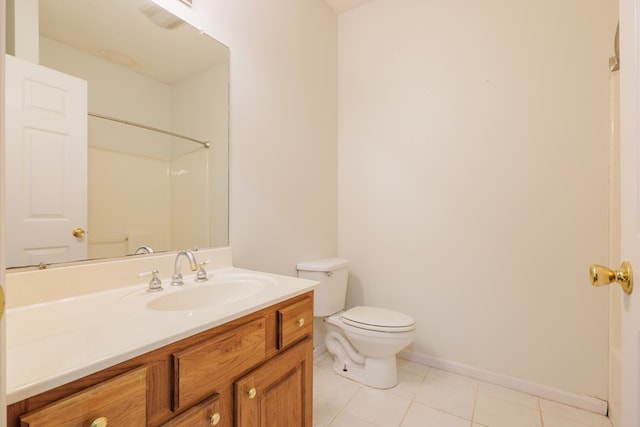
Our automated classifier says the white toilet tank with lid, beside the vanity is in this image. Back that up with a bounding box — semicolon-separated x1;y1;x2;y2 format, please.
297;258;349;317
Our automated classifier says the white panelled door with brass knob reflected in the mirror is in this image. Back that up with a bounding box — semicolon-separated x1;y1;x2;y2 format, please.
5;55;87;267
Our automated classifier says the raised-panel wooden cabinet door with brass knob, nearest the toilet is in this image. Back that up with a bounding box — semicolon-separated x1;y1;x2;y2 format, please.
234;337;313;427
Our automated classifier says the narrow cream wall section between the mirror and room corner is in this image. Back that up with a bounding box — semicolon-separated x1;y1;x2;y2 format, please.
155;0;337;275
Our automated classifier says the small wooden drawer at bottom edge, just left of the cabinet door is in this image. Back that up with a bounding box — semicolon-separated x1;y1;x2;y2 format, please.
162;390;233;427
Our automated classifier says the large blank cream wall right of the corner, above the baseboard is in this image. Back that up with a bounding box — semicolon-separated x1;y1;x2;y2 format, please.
338;0;617;399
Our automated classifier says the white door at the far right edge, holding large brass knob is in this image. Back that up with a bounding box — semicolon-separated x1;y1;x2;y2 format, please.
620;0;640;427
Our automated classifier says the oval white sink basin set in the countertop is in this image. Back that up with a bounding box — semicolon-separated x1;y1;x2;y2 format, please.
147;277;271;311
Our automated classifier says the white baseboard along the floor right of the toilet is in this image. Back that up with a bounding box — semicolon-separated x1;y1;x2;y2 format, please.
398;349;607;415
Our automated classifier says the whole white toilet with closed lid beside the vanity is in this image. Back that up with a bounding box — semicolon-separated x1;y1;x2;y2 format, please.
297;258;416;389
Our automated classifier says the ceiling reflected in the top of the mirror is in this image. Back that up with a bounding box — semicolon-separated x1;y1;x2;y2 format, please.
39;0;228;84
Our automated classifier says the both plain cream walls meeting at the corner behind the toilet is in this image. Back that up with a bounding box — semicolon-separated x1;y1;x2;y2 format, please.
144;0;615;398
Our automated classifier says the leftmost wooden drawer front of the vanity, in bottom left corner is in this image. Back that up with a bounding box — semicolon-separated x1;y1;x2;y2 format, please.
20;367;147;427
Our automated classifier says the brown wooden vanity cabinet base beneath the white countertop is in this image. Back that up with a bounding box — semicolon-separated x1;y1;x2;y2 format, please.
7;292;313;427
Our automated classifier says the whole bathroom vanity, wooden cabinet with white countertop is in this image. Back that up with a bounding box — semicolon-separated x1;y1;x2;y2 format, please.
7;249;315;427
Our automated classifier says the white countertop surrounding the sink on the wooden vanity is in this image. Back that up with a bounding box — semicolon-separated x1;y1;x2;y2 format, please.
6;267;317;404
